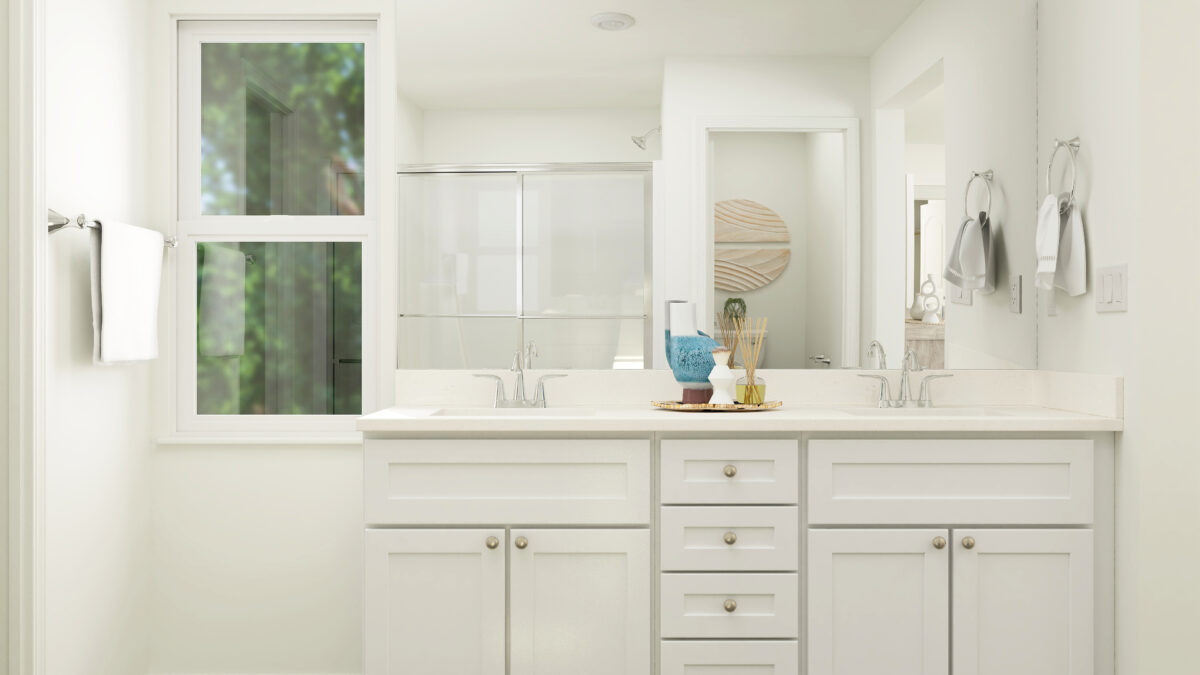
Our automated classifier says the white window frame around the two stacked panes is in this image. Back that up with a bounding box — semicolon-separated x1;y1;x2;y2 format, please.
172;18;383;436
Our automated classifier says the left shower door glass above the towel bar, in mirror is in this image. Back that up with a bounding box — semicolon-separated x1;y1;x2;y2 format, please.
400;174;518;315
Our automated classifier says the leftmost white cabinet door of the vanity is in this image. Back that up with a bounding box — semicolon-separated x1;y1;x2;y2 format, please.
365;530;504;675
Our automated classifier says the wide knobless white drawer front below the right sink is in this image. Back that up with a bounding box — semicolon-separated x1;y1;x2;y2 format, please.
808;440;1093;525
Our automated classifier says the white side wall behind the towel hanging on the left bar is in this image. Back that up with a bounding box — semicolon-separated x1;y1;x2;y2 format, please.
46;0;153;675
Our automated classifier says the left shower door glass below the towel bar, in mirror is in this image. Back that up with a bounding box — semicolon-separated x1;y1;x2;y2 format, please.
396;317;521;370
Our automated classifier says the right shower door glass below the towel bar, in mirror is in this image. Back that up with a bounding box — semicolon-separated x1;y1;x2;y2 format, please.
524;318;646;370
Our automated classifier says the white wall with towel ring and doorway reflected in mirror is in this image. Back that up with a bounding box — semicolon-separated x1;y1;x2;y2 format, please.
864;0;1038;368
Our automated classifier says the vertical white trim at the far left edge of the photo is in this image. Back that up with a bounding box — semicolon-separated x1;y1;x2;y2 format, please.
6;0;47;675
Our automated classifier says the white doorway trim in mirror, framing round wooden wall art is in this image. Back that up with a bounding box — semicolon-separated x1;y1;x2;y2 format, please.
688;115;863;368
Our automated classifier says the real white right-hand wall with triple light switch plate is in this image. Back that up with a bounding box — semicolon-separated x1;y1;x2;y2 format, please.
1038;0;1200;675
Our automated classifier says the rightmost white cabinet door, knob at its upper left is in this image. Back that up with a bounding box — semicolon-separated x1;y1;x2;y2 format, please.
953;530;1096;675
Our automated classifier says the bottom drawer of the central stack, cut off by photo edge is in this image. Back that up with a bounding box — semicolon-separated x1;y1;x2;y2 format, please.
660;640;800;675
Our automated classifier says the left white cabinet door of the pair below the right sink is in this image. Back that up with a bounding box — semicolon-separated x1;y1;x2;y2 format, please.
808;530;950;675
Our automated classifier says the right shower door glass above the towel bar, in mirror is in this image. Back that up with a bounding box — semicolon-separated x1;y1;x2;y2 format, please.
522;173;647;316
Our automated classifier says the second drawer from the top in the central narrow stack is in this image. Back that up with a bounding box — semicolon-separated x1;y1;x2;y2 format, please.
659;507;800;572
